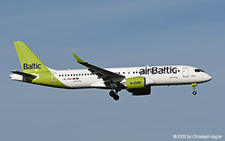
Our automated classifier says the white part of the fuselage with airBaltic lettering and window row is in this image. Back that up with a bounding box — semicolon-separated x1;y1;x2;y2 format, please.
50;65;212;89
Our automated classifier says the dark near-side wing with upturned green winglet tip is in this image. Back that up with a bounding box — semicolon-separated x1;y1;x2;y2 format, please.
73;54;125;88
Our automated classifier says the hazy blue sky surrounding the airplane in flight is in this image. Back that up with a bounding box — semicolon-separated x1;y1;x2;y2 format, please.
0;0;225;141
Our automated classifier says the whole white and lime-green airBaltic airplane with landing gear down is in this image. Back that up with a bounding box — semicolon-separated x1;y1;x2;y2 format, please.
9;41;212;101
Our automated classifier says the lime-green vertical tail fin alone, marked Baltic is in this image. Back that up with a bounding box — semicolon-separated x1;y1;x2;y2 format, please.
14;41;49;73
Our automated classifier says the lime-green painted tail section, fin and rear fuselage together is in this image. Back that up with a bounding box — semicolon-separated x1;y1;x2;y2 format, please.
14;41;69;88
